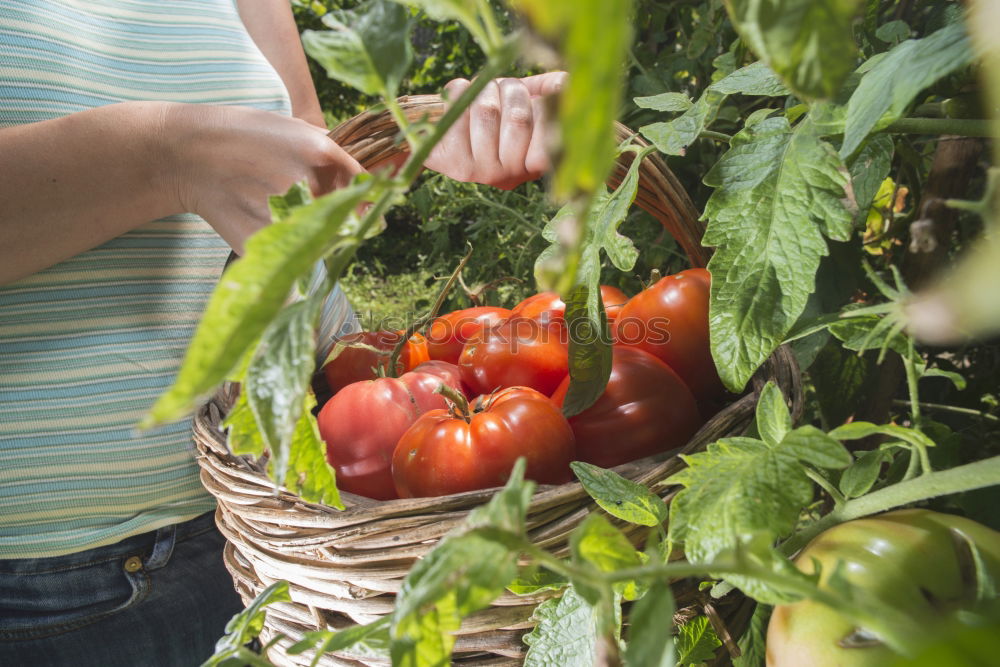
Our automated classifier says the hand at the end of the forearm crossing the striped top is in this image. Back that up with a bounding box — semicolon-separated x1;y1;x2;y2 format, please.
163;104;364;253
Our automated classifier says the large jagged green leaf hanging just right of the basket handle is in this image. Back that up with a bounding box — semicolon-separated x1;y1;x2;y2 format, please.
703;116;852;391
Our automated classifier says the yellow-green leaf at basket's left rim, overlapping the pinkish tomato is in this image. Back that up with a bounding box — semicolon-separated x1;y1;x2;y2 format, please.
278;393;344;510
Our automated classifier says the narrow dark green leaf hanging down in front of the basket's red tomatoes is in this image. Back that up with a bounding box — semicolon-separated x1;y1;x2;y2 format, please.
562;285;611;417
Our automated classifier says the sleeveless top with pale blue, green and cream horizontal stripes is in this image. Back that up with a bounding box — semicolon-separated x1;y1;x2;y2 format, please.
0;0;351;558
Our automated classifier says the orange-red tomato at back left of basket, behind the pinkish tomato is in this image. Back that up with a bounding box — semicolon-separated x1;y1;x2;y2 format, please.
323;331;430;393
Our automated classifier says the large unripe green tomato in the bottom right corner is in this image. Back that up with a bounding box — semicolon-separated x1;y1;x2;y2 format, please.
767;509;1000;667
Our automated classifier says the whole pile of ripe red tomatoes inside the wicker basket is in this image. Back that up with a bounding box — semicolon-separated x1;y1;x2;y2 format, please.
318;269;723;499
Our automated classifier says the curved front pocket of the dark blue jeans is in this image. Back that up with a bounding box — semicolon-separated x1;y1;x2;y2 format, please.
0;554;150;641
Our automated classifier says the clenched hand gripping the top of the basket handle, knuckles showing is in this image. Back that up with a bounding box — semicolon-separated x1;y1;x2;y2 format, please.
424;72;566;190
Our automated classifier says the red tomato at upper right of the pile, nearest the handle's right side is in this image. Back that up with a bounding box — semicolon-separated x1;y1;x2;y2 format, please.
615;269;725;401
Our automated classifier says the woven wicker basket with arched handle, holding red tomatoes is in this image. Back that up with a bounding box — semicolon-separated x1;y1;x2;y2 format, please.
194;95;802;665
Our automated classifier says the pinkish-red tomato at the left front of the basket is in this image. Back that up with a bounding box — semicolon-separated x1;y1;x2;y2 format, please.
316;371;461;500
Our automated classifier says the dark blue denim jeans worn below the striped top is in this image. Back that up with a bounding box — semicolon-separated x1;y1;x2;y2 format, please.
0;513;243;667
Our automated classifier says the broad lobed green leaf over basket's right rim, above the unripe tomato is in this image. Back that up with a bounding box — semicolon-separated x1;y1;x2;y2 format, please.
668;427;851;563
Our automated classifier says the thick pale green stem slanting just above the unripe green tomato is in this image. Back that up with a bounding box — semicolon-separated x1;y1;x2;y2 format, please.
779;452;1000;556
